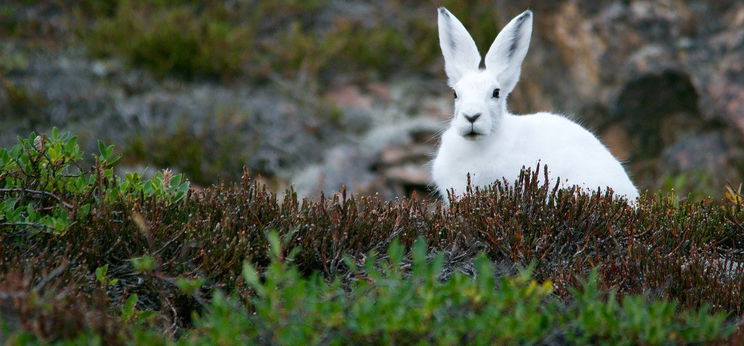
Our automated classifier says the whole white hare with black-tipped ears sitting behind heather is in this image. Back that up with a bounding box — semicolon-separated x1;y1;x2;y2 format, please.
432;7;638;201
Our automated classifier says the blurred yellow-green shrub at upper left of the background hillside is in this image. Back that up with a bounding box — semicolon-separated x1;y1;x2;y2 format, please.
86;1;248;78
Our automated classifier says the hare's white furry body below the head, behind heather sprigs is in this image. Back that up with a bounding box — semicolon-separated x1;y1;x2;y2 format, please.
432;113;638;199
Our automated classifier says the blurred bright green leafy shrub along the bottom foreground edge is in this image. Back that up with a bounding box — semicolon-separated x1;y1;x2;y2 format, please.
186;234;732;345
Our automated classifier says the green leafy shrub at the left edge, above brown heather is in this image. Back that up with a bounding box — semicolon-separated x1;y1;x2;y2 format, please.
0;128;189;233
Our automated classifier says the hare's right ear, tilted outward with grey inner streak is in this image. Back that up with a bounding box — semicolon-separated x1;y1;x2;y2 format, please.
486;10;532;94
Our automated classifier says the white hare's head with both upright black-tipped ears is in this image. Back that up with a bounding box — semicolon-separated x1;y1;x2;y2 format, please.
439;7;532;140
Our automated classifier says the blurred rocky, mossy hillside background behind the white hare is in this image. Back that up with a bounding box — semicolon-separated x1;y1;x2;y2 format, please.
0;0;744;199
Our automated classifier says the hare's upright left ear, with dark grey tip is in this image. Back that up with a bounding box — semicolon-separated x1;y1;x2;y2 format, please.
439;7;481;86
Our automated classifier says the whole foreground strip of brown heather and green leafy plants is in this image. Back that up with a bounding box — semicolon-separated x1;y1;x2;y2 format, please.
0;131;744;344
